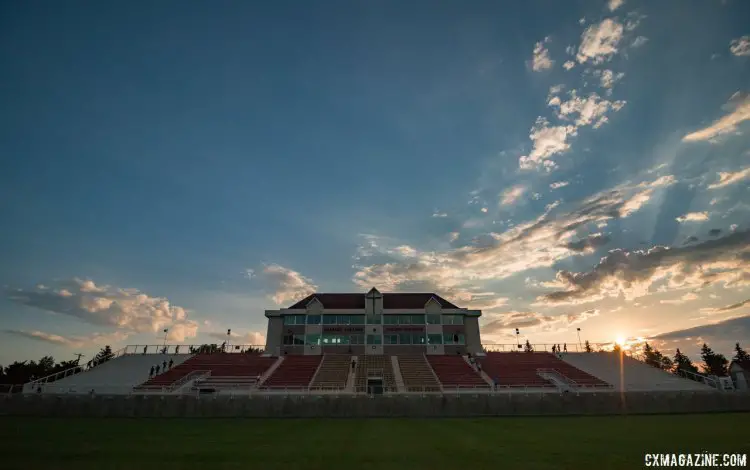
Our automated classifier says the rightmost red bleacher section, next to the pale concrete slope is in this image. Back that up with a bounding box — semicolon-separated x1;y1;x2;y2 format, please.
480;352;608;388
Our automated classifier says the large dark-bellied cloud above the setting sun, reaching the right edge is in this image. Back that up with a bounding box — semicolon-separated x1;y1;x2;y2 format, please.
537;231;750;305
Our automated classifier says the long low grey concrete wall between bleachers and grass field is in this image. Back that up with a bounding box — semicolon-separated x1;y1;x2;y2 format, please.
0;392;750;418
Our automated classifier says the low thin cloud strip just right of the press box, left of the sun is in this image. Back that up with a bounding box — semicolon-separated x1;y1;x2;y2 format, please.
480;309;599;336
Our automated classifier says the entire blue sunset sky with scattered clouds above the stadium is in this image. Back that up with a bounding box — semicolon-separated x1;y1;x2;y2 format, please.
0;0;750;364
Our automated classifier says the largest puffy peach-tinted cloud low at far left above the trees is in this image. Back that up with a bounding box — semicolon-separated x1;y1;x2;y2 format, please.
6;278;198;341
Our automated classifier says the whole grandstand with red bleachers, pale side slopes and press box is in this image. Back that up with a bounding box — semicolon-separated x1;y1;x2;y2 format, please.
24;289;736;395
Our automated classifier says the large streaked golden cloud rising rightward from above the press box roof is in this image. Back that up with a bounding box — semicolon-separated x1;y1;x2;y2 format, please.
353;177;674;300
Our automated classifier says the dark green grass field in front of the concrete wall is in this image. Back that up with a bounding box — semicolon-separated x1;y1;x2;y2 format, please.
0;414;750;470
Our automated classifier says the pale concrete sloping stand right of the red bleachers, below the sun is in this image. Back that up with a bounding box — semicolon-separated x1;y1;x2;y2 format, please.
561;352;715;392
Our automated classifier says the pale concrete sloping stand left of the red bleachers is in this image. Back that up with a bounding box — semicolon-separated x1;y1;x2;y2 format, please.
24;354;191;394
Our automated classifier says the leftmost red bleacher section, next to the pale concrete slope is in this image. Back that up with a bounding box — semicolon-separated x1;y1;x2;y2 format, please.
135;353;277;391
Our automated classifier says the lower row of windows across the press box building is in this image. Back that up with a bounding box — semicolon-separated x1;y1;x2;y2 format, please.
283;333;466;346
